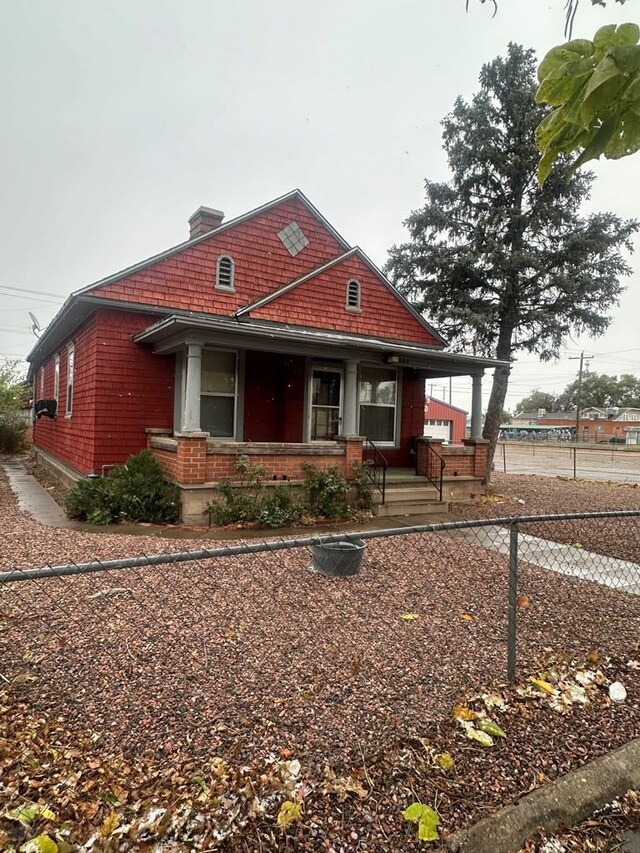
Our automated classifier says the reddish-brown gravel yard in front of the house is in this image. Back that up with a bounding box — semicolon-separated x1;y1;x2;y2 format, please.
0;466;640;853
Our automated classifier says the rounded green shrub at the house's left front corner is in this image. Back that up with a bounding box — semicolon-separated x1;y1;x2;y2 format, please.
65;450;180;524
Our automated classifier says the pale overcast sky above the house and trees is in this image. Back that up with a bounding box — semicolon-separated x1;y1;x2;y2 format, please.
0;0;640;407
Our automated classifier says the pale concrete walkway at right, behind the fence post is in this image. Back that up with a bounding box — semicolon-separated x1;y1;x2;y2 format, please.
449;526;640;595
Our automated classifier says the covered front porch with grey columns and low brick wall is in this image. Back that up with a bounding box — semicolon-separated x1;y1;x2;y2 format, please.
134;316;496;523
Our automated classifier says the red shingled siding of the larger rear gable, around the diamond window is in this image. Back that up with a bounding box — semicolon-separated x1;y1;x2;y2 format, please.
91;200;344;316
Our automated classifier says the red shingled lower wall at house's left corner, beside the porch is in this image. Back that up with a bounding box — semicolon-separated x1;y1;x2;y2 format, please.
34;311;174;474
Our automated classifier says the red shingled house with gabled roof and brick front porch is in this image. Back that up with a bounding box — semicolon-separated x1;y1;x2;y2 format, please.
28;190;498;521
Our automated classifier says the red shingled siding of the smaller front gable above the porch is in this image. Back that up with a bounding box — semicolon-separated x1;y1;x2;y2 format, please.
251;257;439;344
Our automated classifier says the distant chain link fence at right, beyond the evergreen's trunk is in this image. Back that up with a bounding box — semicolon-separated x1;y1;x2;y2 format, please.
494;441;640;483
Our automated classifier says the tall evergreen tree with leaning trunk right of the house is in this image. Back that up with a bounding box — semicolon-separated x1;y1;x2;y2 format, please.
386;44;638;467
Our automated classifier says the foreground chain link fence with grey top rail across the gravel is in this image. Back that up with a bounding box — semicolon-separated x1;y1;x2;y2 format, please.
0;511;640;850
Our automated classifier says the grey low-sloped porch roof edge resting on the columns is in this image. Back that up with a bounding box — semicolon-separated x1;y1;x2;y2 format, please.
134;313;508;376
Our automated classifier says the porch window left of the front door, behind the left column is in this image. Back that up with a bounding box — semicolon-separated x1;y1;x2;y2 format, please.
200;349;238;438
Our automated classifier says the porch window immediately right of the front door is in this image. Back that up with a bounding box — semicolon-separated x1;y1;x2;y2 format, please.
358;365;398;445
